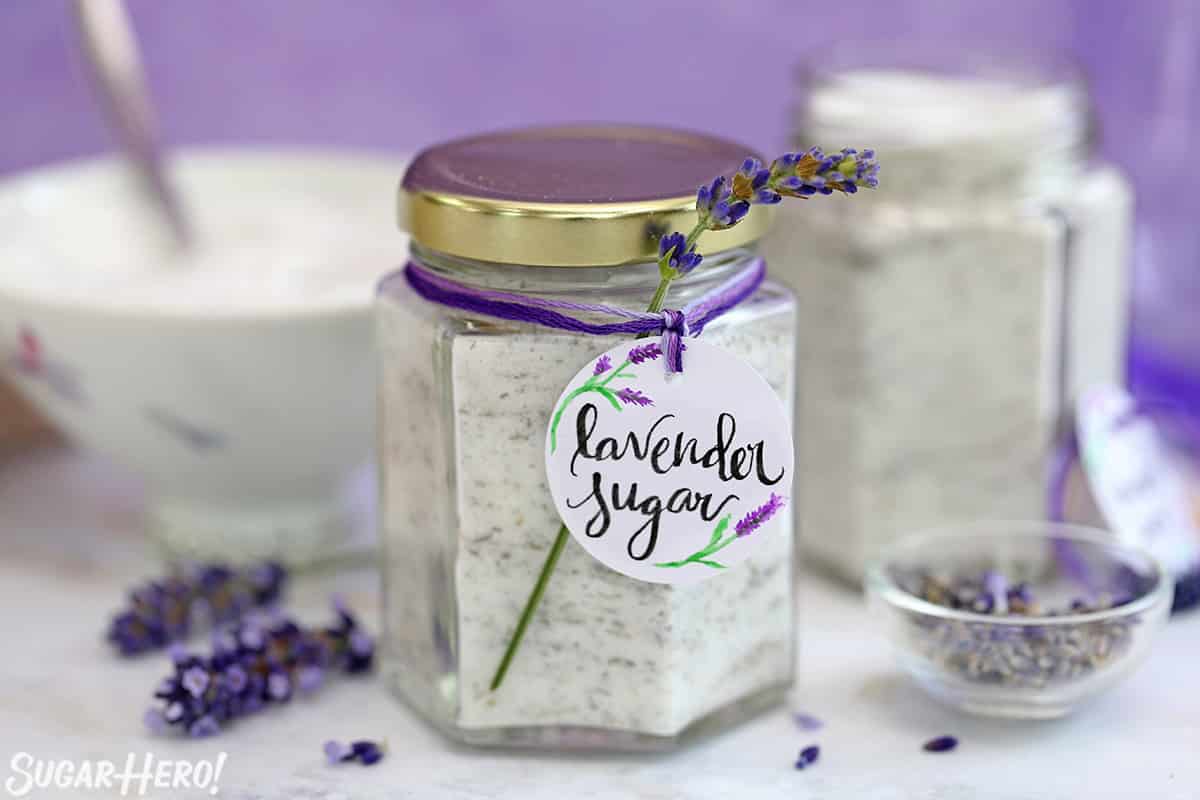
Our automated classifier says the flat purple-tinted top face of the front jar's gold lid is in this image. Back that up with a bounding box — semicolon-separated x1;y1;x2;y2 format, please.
403;125;755;204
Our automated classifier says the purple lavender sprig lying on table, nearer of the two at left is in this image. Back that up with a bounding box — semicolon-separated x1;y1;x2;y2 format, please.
144;602;374;736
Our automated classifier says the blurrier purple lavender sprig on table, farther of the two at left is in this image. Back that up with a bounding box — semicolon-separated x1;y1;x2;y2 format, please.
106;561;287;656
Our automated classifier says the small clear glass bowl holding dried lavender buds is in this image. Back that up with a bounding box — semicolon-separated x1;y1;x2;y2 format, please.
866;522;1172;720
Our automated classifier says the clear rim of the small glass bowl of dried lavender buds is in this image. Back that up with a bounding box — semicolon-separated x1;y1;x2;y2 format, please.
864;521;1174;627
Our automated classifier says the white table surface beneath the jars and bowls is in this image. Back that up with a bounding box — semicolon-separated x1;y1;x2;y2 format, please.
0;452;1200;800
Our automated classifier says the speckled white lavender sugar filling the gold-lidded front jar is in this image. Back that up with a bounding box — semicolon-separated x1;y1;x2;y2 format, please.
379;287;793;735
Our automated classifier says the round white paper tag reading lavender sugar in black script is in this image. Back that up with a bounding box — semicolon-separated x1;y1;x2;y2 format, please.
546;339;792;584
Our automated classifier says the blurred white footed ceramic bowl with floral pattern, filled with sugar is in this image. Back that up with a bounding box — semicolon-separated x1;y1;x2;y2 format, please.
0;150;407;563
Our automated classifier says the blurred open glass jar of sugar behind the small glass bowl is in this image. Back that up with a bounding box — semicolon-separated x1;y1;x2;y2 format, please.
764;48;1132;581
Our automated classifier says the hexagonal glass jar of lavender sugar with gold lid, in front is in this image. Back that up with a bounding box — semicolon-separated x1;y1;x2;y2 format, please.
377;127;796;750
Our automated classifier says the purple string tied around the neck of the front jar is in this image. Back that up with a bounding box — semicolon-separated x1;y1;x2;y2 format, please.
404;258;767;372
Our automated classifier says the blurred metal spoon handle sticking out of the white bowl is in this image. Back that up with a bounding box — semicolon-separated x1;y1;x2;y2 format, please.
74;0;192;247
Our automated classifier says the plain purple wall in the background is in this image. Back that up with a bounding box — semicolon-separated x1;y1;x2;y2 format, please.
0;0;1200;393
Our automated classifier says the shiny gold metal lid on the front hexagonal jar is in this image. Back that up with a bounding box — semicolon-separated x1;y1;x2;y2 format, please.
398;126;773;266
